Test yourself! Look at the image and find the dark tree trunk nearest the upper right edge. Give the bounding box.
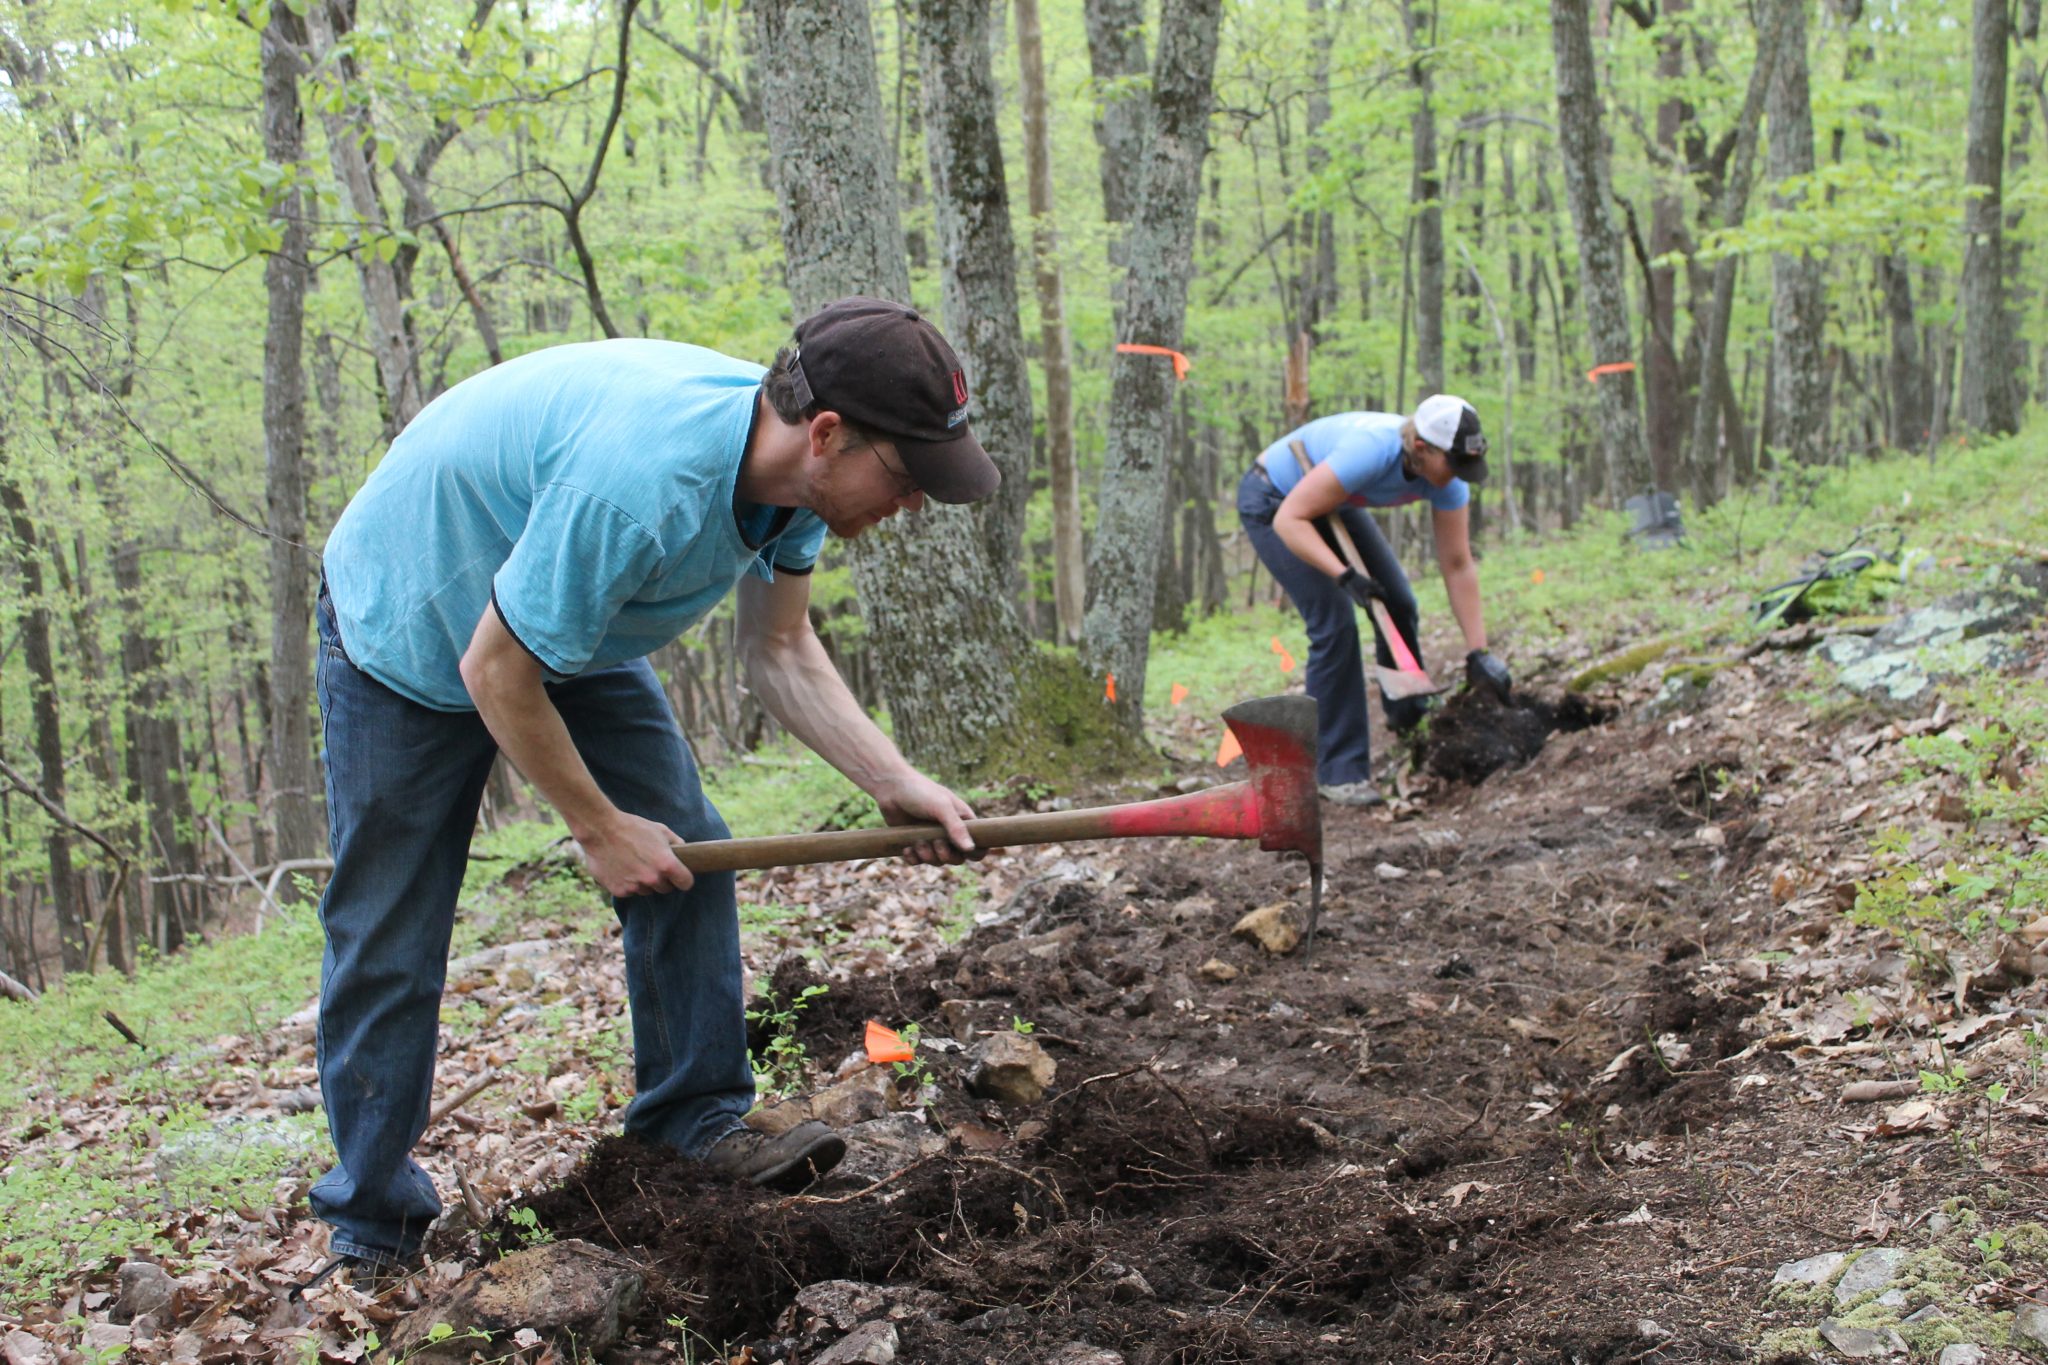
[1956,0,2019,436]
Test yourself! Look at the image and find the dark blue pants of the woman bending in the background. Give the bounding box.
[1237,467,1430,786]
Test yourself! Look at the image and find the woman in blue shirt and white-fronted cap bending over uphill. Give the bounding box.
[1237,393,1511,806]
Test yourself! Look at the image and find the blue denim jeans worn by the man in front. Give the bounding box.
[311,585,754,1261]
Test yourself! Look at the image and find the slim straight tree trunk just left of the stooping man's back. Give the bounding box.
[262,4,325,857]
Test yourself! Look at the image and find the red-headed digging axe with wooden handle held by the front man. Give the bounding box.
[676,696,1323,956]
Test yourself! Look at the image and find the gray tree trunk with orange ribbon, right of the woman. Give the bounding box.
[1550,0,1653,503]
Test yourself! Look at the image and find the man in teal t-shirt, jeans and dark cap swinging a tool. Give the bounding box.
[311,299,999,1275]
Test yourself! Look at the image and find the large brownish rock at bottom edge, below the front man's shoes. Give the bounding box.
[389,1238,641,1365]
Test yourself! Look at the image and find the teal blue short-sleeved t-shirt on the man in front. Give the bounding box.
[324,340,825,710]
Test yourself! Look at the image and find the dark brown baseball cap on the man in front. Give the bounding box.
[788,295,1004,503]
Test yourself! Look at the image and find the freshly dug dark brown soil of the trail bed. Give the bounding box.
[512,654,2044,1363]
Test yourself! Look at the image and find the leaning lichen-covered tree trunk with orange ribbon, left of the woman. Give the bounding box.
[1081,0,1223,735]
